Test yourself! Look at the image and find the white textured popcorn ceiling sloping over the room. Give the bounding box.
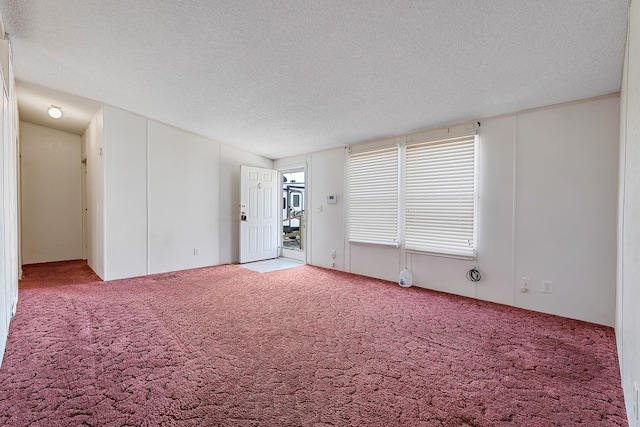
[0,0,629,158]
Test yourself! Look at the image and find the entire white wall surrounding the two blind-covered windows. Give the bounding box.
[275,96,619,326]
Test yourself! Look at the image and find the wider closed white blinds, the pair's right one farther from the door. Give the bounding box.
[405,135,476,256]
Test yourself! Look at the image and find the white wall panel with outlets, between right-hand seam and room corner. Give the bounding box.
[515,98,620,326]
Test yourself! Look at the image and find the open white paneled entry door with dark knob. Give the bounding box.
[240,166,280,264]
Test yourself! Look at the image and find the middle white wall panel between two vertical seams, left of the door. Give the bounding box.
[148,120,220,273]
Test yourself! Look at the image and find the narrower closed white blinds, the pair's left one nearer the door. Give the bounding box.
[348,146,398,245]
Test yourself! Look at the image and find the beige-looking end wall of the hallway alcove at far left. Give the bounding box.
[20,121,82,264]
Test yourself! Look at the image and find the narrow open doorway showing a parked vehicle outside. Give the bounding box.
[281,168,306,262]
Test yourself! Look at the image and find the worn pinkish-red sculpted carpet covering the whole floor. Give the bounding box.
[0,263,627,427]
